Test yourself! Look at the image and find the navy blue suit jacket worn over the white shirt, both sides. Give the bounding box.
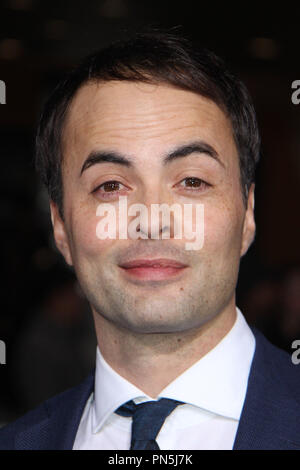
[0,329,300,450]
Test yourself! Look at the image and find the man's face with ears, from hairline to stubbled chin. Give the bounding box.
[51,82,255,333]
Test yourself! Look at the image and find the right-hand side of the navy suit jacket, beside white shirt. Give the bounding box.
[233,329,300,450]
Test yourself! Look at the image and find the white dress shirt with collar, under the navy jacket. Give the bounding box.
[73,308,255,450]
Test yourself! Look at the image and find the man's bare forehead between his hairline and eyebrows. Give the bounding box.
[63,81,236,167]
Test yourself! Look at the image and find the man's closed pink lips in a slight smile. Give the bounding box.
[120,258,187,281]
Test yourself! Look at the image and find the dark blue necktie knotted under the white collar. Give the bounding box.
[115,398,184,450]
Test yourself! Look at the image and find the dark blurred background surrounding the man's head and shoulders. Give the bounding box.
[0,0,300,425]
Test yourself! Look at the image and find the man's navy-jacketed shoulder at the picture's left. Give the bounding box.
[0,372,94,450]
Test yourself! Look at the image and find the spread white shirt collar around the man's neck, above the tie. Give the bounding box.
[92,307,255,432]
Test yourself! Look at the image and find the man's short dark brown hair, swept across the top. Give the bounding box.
[36,30,260,216]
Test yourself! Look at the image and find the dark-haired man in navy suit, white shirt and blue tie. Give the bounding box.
[0,32,300,450]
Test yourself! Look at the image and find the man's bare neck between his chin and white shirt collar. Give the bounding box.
[93,299,236,398]
